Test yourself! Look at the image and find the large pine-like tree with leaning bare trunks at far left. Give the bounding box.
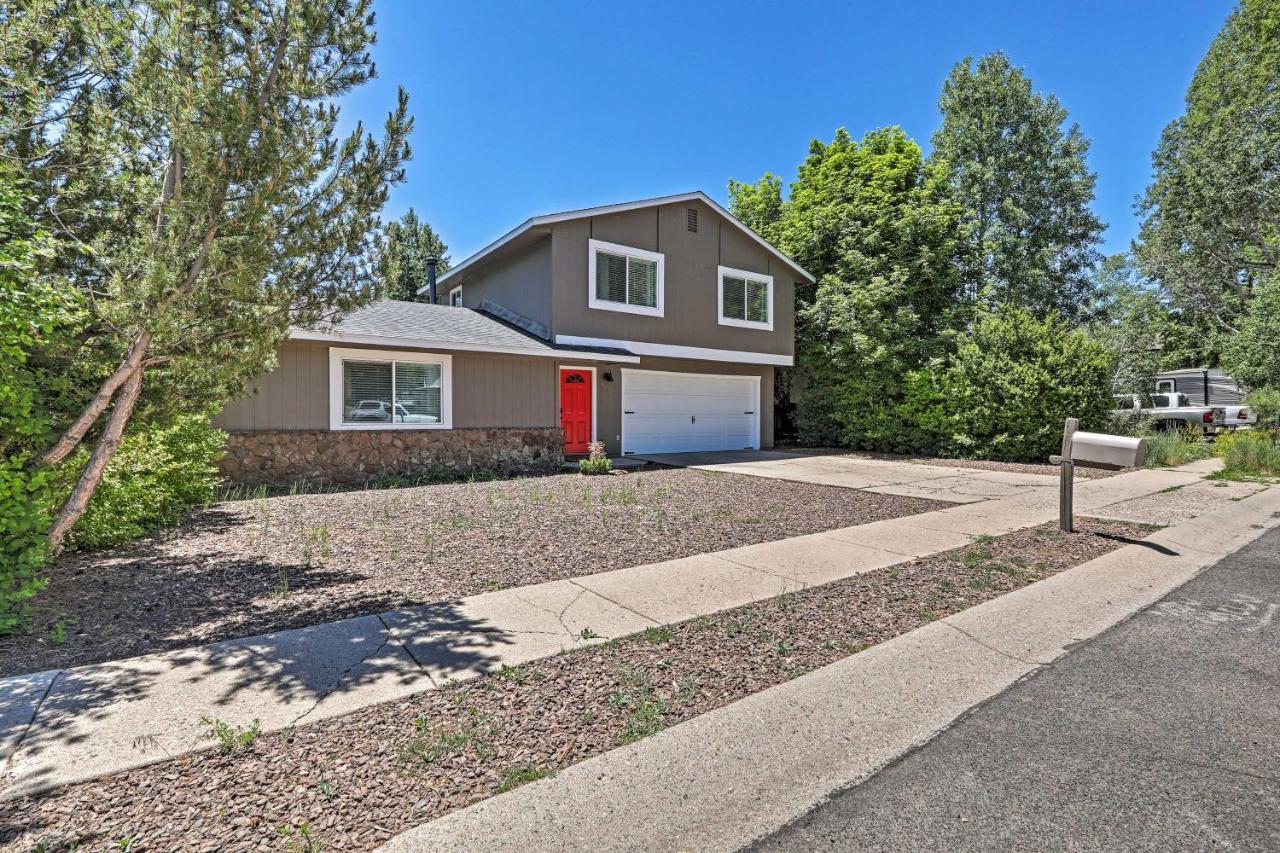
[0,0,411,549]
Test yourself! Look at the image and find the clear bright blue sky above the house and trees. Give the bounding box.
[344,0,1234,260]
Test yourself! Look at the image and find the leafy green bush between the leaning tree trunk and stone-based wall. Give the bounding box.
[64,415,227,549]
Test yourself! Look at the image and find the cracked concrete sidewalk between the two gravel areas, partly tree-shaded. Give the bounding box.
[0,461,1228,797]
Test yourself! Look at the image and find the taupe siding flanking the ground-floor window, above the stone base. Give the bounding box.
[214,341,559,432]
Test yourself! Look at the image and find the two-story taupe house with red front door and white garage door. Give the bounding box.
[215,192,813,482]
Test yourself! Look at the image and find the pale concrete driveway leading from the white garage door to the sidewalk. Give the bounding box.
[639,450,1057,503]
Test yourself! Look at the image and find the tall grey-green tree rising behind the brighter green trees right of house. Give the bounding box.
[932,53,1103,318]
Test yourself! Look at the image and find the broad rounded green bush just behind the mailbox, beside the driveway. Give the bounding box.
[897,309,1115,461]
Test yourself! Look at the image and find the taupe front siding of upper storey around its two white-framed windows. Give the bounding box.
[552,201,801,356]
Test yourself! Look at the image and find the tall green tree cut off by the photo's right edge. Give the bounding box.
[1135,0,1280,332]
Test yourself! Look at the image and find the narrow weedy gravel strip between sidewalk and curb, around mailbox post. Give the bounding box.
[0,514,1151,853]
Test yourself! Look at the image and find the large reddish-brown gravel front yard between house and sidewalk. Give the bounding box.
[0,469,948,675]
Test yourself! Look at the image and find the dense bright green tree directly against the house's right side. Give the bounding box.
[731,127,959,448]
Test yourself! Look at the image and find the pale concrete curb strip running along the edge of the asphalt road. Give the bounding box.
[384,479,1280,853]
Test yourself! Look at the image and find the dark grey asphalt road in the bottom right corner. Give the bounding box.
[750,529,1280,852]
